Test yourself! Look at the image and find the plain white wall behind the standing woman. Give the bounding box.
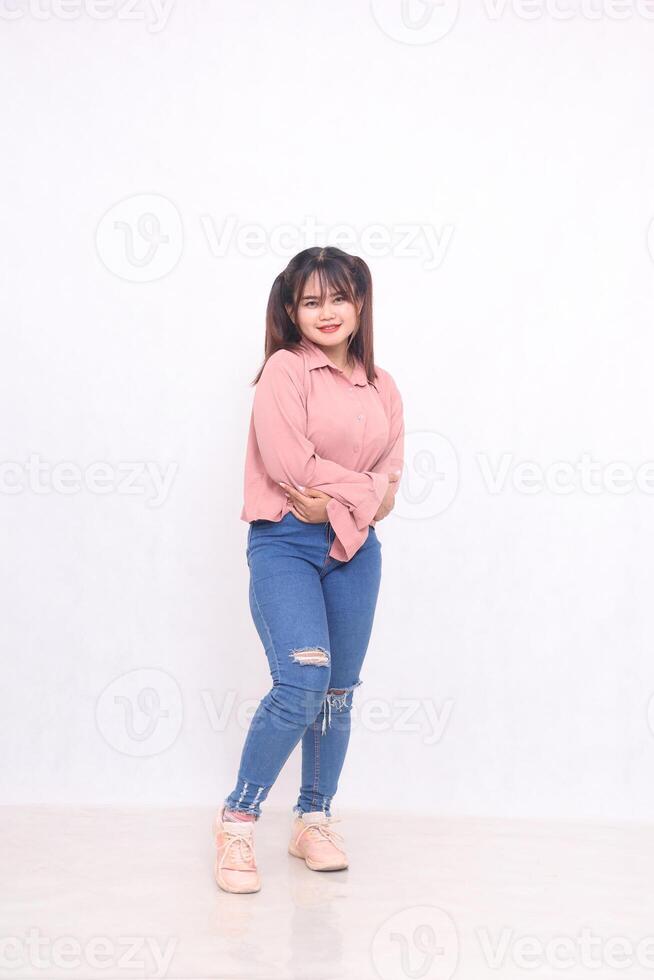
[0,0,654,818]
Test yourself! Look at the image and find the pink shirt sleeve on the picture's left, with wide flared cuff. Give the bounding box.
[252,352,390,561]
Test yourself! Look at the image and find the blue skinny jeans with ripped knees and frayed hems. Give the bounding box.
[225,511,382,820]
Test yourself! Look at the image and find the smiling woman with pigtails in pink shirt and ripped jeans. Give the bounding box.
[215,247,404,892]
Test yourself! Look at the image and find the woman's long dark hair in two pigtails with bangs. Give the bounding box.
[251,245,376,385]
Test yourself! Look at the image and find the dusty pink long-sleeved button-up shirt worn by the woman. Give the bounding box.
[241,337,404,561]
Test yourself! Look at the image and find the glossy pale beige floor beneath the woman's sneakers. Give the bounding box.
[0,807,654,980]
